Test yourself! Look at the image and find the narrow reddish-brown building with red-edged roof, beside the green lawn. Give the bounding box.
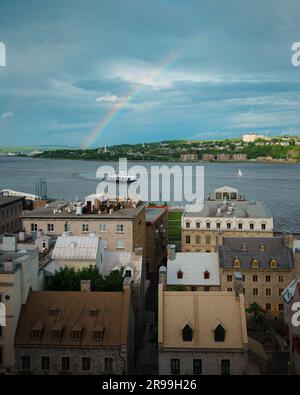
[145,206,168,273]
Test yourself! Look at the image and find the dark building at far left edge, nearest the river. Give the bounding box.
[0,196,23,235]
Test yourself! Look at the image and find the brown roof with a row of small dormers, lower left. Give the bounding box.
[15,289,131,348]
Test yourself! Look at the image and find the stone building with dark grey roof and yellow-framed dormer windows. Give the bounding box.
[219,237,294,318]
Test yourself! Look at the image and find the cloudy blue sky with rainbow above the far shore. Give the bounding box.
[0,0,300,148]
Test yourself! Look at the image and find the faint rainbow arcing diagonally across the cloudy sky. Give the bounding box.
[81,50,182,149]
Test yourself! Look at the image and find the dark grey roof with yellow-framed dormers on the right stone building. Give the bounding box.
[219,237,293,270]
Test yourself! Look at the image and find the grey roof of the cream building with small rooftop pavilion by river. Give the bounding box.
[184,200,272,218]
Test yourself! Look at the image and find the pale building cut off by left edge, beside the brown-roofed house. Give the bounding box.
[0,251,42,373]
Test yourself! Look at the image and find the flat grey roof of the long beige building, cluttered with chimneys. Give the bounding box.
[22,202,144,219]
